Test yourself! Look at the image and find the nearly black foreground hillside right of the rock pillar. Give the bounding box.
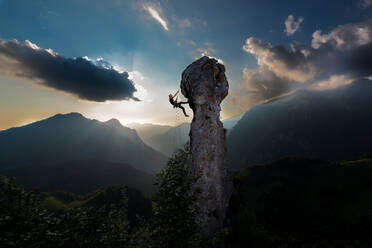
[230,157,372,247]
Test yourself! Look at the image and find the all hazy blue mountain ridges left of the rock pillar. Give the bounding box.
[0,110,243,194]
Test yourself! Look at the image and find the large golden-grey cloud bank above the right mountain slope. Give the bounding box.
[235,19,372,108]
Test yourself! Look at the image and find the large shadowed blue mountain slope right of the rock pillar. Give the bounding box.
[228,80,372,169]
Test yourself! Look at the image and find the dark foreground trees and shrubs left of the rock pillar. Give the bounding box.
[0,146,198,248]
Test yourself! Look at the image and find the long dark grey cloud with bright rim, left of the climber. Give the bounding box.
[0,39,139,102]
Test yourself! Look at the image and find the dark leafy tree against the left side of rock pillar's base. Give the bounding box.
[152,146,199,248]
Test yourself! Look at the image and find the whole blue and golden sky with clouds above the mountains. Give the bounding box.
[0,0,372,129]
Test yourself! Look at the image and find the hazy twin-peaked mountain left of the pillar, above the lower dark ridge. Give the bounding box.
[0,113,166,173]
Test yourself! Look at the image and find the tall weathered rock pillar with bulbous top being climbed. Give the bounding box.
[181,57,232,237]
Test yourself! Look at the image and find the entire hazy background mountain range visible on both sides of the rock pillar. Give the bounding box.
[0,80,372,193]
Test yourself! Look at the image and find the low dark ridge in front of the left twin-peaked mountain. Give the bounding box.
[2,160,155,195]
